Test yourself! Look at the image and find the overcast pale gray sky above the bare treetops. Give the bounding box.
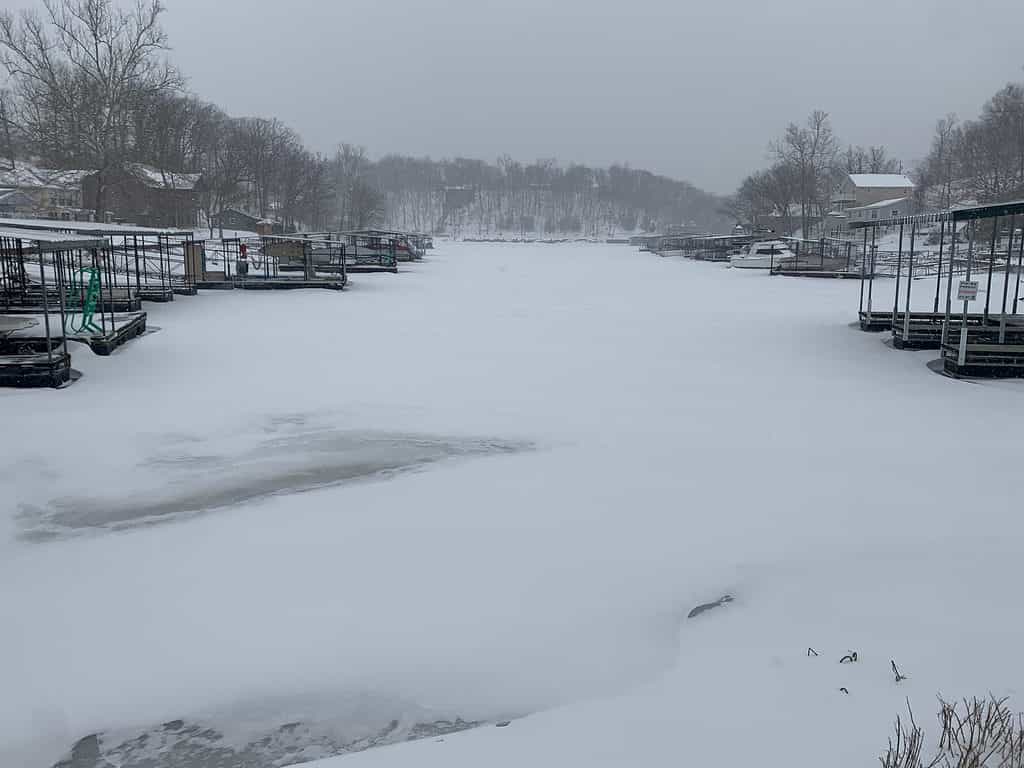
[155,0,1024,193]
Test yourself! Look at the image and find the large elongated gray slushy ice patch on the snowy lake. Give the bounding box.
[18,423,532,541]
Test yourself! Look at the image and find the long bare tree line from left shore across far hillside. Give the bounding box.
[0,0,723,234]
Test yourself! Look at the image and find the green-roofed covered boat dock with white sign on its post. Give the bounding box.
[851,201,1024,377]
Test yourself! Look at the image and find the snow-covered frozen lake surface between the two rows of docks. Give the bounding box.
[0,243,1024,768]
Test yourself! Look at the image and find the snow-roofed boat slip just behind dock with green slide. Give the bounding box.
[0,219,197,308]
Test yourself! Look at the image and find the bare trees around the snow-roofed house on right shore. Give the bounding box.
[726,83,1024,234]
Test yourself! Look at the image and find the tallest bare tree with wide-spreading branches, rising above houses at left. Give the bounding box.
[0,0,182,215]
